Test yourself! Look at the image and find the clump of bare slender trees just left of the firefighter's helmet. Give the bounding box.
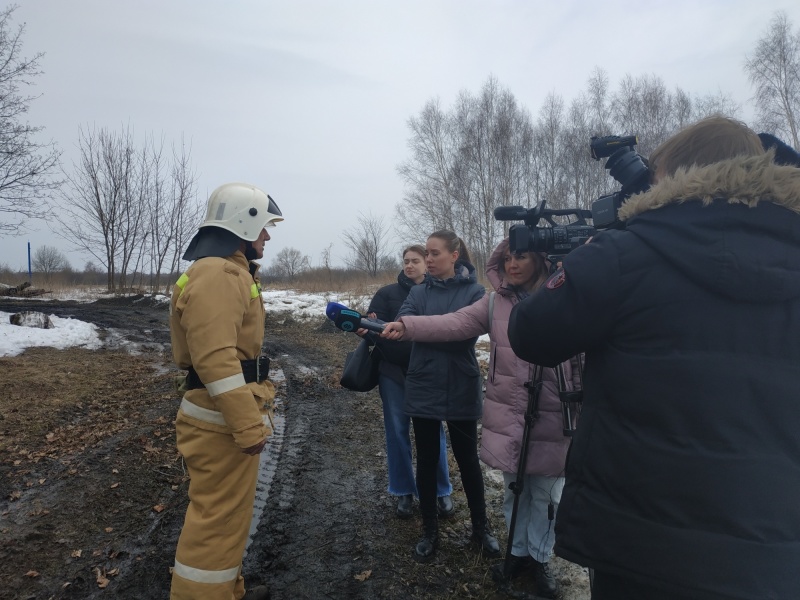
[57,129,201,291]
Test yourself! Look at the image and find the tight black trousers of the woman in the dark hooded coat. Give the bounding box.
[411,417,486,523]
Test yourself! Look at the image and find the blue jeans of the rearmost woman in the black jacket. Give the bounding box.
[378,374,453,496]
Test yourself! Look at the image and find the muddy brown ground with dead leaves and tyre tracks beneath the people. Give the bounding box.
[0,298,589,600]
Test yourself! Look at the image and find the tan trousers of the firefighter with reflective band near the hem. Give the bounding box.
[170,419,259,600]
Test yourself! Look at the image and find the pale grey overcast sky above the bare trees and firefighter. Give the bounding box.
[6,0,800,269]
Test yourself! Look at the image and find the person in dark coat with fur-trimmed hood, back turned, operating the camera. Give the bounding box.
[509,117,800,600]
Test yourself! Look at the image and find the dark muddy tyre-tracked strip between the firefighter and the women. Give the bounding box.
[244,355,383,598]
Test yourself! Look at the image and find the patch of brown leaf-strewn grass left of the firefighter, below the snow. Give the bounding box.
[0,349,177,474]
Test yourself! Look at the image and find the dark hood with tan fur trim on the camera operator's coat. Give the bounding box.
[601,152,800,303]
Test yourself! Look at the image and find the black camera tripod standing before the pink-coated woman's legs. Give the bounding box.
[499,355,593,599]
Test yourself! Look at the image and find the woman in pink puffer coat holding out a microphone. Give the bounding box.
[382,239,579,598]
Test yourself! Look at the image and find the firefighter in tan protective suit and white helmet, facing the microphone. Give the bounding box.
[170,183,283,600]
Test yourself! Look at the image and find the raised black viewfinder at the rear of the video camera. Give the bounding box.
[589,135,650,229]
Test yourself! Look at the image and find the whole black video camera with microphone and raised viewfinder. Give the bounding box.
[494,135,650,264]
